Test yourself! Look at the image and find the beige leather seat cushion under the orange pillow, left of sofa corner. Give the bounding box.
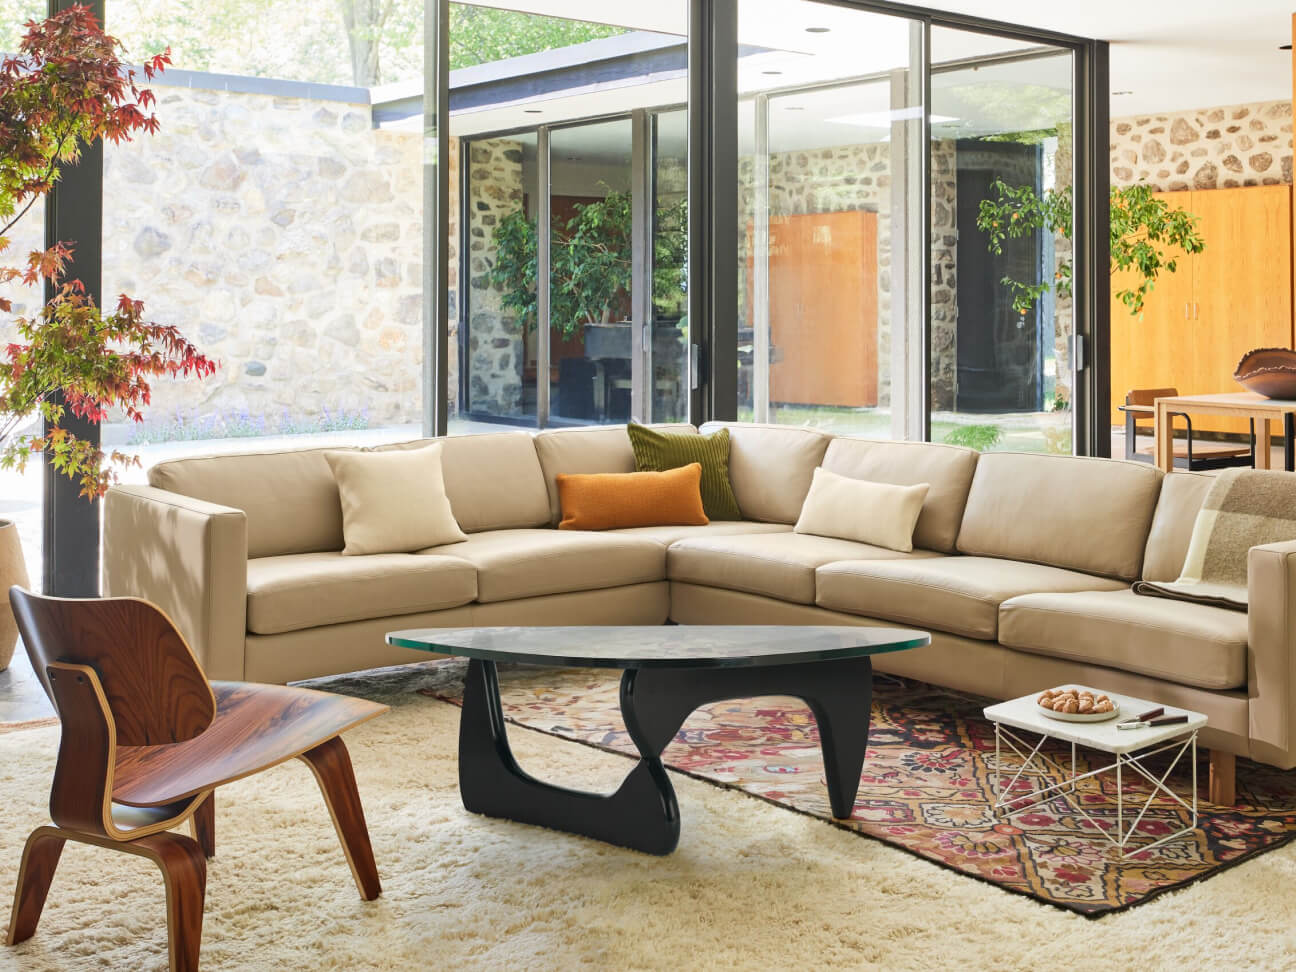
[420,529,666,604]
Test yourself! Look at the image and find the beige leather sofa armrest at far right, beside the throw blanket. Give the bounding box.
[1247,540,1296,770]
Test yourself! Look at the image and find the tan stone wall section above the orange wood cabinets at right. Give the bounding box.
[1111,101,1292,192]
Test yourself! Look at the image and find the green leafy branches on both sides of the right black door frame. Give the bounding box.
[976,180,1205,314]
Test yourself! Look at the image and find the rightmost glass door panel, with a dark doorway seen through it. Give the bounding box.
[931,29,1074,454]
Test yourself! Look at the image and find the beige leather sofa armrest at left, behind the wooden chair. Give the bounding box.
[104,486,248,680]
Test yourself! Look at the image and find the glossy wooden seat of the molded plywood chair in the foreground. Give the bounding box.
[113,682,388,807]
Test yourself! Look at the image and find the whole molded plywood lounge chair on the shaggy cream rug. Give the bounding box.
[6,587,388,969]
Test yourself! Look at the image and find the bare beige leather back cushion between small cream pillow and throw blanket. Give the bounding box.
[958,452,1163,581]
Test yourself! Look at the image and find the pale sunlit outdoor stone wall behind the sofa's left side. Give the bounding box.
[104,86,422,426]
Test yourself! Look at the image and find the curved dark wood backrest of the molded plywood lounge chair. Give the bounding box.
[9,587,216,746]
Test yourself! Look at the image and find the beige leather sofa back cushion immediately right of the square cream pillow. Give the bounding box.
[441,432,550,533]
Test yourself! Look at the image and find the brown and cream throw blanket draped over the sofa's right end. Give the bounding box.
[1134,469,1296,610]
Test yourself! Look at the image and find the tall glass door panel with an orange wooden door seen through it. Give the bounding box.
[739,0,924,438]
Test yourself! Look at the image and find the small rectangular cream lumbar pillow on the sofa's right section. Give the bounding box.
[793,467,932,553]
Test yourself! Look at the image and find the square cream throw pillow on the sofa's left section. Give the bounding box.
[324,442,468,556]
